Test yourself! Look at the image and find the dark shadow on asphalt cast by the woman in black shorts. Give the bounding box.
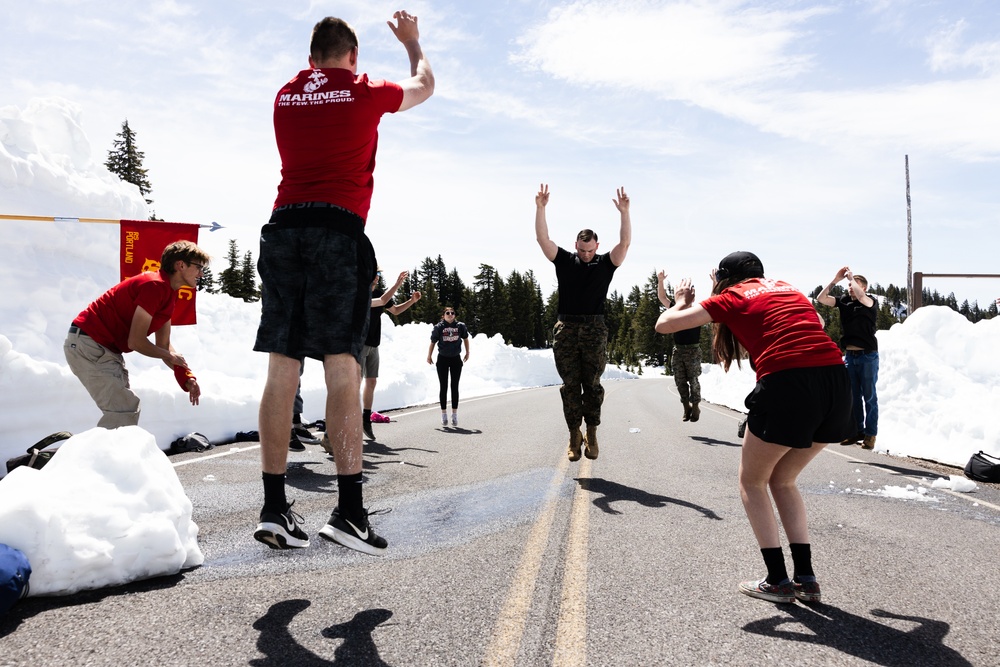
[743,604,972,667]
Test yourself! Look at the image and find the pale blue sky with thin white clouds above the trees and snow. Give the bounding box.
[0,0,1000,307]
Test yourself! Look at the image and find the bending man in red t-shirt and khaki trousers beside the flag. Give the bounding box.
[63,241,211,428]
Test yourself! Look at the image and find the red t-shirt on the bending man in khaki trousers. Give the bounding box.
[73,271,177,354]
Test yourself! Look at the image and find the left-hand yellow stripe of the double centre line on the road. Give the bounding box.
[483,456,569,667]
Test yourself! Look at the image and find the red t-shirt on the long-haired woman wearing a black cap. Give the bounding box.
[701,278,844,380]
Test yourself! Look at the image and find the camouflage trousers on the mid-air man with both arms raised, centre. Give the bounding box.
[552,321,608,430]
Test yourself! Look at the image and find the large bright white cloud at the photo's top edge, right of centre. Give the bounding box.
[515,0,828,96]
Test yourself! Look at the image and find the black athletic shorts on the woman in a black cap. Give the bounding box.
[744,364,855,449]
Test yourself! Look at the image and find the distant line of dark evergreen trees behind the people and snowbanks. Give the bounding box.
[198,241,997,373]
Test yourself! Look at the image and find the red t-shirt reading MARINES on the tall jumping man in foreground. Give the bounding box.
[274,68,403,219]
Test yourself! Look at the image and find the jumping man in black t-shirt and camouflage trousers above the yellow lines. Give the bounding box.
[535,184,632,461]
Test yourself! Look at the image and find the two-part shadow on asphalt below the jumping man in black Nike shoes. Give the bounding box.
[249,600,392,667]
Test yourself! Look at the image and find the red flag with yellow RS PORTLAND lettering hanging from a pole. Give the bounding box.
[120,220,198,326]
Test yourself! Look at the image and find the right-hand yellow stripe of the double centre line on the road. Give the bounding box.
[552,458,590,667]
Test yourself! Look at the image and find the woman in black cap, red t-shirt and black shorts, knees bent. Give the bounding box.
[656,251,853,602]
